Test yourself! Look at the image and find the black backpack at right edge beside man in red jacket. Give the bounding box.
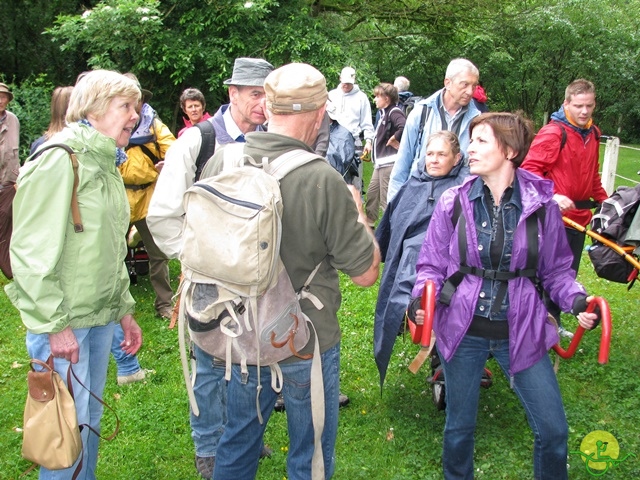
[588,184,640,288]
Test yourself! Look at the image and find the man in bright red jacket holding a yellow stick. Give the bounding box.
[522,79,608,336]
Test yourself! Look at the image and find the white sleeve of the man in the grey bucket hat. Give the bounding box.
[147,128,202,258]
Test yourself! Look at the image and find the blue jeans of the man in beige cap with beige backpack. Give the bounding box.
[213,344,340,480]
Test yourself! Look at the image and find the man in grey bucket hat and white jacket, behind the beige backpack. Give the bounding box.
[147,58,273,479]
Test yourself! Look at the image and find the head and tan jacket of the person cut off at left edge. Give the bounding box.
[0,83,20,185]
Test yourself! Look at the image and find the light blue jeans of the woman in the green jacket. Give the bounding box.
[27,322,115,480]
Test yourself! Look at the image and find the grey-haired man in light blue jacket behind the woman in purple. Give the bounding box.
[387,58,480,202]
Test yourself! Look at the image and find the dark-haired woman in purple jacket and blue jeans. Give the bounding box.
[410,113,598,480]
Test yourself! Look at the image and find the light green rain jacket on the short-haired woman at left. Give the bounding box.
[5,123,135,334]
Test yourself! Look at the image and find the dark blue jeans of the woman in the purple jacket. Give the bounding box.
[442,335,568,480]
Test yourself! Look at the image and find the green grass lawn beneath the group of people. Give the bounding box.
[0,149,640,480]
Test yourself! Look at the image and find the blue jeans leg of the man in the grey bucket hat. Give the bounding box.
[190,344,227,457]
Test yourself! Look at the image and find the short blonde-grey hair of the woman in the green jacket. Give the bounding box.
[67,70,142,123]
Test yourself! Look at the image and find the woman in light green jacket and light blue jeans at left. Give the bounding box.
[6,70,142,480]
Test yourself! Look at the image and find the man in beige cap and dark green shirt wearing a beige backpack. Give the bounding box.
[203,63,380,480]
